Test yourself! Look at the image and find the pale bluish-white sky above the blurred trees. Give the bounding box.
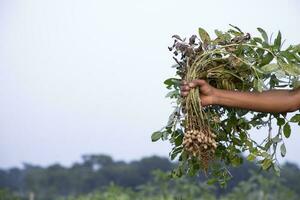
[0,0,300,168]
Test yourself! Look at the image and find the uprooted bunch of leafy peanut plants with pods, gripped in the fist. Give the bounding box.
[152,25,300,186]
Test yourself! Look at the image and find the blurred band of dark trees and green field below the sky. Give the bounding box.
[0,155,300,200]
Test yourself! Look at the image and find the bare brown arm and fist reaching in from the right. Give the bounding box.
[180,79,300,113]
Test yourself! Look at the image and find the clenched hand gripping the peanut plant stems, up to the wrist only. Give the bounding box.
[180,79,216,106]
